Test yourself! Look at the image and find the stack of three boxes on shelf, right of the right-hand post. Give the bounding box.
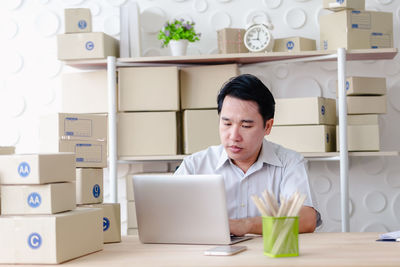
[337,77,387,151]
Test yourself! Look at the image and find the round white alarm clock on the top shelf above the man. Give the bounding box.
[244,24,274,52]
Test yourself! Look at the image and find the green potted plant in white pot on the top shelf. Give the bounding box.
[158,19,201,56]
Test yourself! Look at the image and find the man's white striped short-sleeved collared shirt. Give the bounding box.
[175,139,314,219]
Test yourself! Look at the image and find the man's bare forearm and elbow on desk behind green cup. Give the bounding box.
[229,206,317,236]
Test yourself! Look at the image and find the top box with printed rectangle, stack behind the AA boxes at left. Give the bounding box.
[39,113,107,144]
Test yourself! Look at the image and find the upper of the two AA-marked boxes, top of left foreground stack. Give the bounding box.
[0,153,75,184]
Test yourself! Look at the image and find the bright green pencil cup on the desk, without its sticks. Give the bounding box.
[262,216,299,258]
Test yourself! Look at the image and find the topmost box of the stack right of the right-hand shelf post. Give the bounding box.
[340,77,386,95]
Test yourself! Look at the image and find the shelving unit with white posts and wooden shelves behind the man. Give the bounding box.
[67,48,399,232]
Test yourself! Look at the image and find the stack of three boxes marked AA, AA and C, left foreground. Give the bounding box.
[0,153,103,264]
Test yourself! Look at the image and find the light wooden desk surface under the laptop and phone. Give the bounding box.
[10,233,400,267]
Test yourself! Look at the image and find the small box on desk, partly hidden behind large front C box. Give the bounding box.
[80,203,121,243]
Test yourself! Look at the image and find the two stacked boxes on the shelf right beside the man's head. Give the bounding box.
[265,97,336,152]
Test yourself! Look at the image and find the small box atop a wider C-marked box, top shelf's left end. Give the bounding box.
[57,8,119,60]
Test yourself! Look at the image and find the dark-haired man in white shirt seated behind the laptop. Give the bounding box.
[175,74,319,236]
